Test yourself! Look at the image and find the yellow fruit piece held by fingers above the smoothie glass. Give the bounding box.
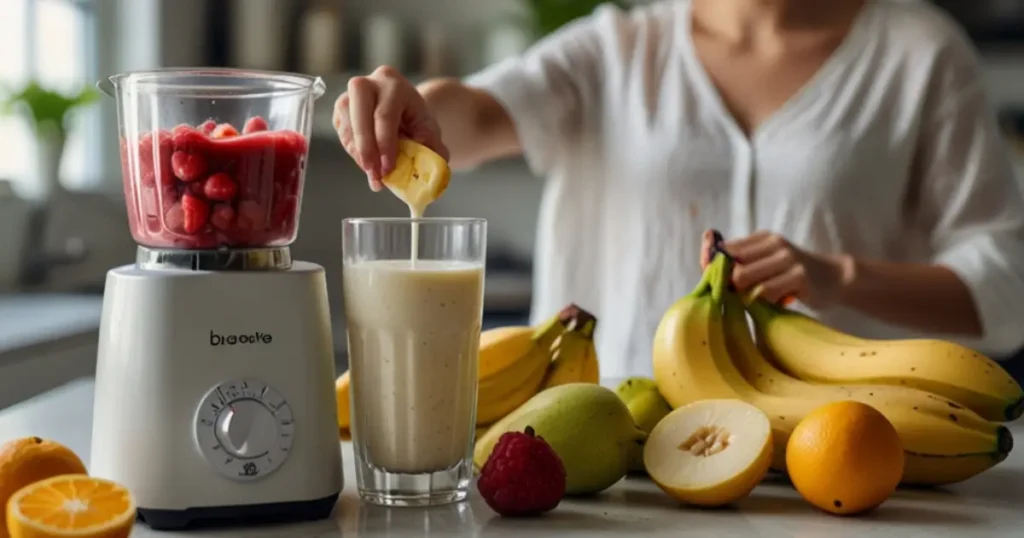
[381,138,452,216]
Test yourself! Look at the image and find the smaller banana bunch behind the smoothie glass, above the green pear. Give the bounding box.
[476,304,600,426]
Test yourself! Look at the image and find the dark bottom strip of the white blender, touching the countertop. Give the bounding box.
[138,492,341,531]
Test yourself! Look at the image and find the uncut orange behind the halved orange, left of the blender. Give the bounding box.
[0,438,86,538]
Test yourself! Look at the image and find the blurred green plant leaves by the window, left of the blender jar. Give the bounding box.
[0,81,99,138]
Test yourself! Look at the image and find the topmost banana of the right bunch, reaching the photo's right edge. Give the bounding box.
[748,300,1024,421]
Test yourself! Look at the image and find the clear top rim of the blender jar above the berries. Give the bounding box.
[96,68,327,99]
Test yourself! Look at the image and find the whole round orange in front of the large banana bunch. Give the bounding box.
[785,402,903,515]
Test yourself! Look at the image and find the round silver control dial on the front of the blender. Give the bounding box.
[195,380,295,481]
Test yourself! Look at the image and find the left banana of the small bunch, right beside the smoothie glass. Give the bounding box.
[476,316,565,425]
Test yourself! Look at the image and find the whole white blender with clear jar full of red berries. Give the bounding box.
[90,69,342,529]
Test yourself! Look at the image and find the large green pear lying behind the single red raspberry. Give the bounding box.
[473,383,647,496]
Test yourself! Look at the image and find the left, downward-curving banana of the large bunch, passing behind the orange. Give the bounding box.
[653,255,1013,484]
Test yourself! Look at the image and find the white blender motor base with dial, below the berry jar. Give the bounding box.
[88,252,344,529]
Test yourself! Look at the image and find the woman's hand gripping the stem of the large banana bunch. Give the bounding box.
[700,231,850,308]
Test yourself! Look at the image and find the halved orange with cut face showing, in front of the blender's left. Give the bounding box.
[7,474,135,538]
